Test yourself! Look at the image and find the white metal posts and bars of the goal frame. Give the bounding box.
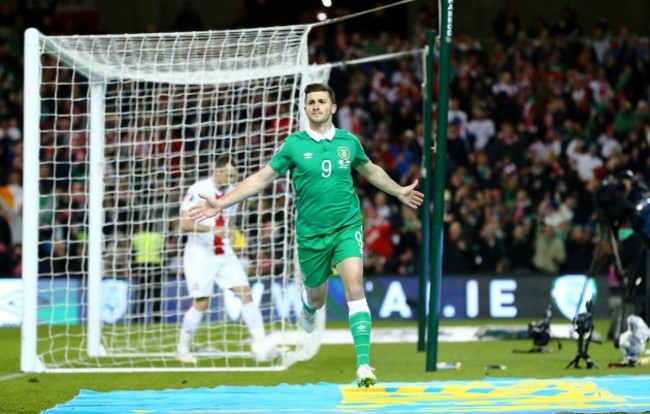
[20,25,330,372]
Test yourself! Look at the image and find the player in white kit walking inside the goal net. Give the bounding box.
[177,156,278,363]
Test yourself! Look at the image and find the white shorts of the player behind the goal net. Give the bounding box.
[183,243,249,298]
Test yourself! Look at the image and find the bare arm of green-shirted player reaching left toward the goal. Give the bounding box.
[189,165,279,221]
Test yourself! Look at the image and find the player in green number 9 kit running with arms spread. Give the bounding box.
[190,83,423,387]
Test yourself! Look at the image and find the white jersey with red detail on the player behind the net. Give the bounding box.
[181,177,237,250]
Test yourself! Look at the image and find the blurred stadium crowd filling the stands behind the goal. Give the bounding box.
[0,0,650,277]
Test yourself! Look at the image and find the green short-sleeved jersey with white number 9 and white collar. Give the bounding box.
[270,129,369,237]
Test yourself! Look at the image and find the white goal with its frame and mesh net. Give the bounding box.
[21,25,329,372]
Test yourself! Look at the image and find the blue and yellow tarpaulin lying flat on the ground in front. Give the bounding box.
[44,375,650,414]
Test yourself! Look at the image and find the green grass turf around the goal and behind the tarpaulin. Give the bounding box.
[0,320,650,414]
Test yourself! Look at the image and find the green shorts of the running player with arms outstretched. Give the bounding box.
[298,223,363,287]
